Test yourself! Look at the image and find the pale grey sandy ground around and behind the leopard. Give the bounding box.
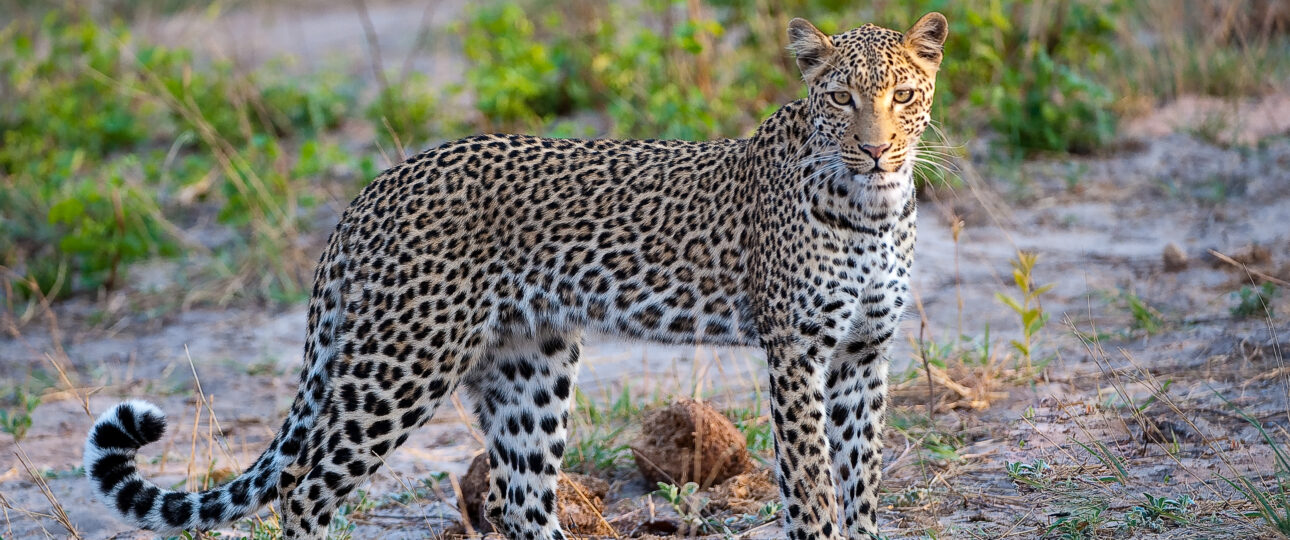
[0,3,1290,539]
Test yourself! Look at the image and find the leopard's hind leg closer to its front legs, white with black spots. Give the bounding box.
[467,331,582,540]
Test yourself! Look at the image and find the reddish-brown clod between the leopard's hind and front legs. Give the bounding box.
[632,400,752,487]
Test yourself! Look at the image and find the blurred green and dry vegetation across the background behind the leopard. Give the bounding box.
[0,0,1290,304]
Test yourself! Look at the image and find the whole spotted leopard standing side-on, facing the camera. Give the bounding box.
[84,13,948,540]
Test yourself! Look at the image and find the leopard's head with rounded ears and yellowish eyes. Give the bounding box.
[788,13,948,184]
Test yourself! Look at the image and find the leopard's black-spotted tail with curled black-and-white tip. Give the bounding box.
[84,230,348,534]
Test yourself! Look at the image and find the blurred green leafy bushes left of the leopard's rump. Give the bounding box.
[0,12,357,300]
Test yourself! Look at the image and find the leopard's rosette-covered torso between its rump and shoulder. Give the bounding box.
[343,135,756,344]
